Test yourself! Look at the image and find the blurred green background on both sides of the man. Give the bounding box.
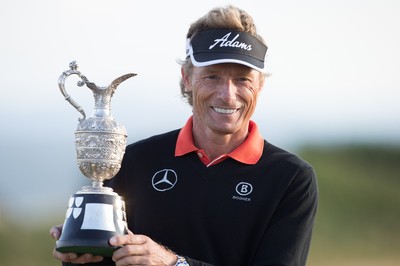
[0,145,400,266]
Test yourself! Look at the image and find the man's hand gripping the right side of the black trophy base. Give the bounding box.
[110,232,177,266]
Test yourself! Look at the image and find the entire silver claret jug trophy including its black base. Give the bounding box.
[56,61,136,257]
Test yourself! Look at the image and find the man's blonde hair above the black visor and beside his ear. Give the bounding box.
[179,5,265,105]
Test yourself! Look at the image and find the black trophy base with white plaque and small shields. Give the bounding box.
[56,192,127,257]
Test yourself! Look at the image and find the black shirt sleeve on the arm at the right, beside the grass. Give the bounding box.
[252,164,318,266]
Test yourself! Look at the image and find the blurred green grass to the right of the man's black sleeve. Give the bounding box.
[301,146,400,266]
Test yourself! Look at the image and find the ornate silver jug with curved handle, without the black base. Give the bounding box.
[58,61,136,192]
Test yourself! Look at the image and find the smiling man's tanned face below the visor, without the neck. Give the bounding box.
[184,64,263,135]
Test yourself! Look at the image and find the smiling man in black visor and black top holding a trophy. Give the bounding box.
[50,6,317,266]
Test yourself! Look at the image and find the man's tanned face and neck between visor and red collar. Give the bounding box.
[182,63,263,164]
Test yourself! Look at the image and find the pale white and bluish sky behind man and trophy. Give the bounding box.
[0,0,400,221]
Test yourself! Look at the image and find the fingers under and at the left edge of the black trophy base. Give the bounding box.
[50,224,103,264]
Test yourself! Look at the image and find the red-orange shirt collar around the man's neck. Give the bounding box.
[175,117,264,165]
